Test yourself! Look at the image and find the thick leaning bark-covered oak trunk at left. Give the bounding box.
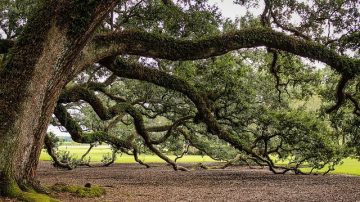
[0,0,116,200]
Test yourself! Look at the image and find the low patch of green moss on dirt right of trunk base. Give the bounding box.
[50,184,106,198]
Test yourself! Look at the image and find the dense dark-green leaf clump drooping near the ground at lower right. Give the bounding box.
[266,111,346,169]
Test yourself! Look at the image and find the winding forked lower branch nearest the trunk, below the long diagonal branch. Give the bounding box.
[54,82,191,171]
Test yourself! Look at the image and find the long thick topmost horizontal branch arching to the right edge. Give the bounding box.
[88,28,360,75]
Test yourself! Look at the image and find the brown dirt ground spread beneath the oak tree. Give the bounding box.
[2,162,360,202]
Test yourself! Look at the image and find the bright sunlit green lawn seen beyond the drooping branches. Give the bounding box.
[40,145,360,176]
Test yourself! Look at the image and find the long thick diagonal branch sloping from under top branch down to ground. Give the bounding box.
[102,57,332,174]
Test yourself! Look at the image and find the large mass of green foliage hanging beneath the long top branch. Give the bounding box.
[66,34,349,170]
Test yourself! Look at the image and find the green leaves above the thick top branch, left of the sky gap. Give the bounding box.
[117,0,221,38]
